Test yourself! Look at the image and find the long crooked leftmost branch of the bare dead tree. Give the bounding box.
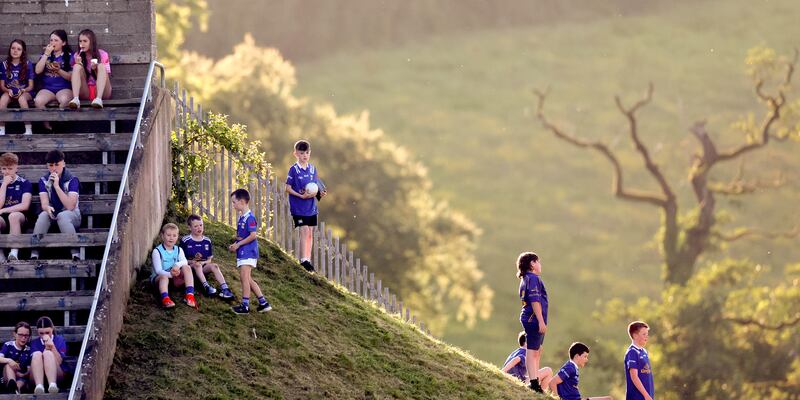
[534,89,667,207]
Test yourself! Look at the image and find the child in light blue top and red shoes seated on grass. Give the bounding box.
[150,223,197,308]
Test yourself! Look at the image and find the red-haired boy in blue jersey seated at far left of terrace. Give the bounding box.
[0,153,33,262]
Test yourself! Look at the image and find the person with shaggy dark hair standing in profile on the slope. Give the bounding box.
[517,252,548,393]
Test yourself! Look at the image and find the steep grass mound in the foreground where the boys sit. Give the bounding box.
[106,211,544,399]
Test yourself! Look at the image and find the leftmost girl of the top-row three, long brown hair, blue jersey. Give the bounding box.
[0,39,36,135]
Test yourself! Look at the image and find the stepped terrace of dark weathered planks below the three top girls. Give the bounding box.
[0,98,140,399]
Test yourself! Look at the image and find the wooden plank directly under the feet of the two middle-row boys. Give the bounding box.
[0,260,100,279]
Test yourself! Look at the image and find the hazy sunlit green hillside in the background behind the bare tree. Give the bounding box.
[297,0,800,392]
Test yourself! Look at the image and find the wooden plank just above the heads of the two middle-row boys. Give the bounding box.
[0,133,131,153]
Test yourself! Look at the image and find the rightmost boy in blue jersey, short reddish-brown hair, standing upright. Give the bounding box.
[625,321,655,400]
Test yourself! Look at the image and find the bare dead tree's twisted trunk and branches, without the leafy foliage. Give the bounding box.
[534,50,800,285]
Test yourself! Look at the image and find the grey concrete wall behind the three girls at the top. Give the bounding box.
[0,0,156,99]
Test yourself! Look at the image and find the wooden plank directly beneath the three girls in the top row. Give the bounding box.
[0,107,139,122]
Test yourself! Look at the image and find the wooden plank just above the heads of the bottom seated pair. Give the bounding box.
[0,290,94,312]
